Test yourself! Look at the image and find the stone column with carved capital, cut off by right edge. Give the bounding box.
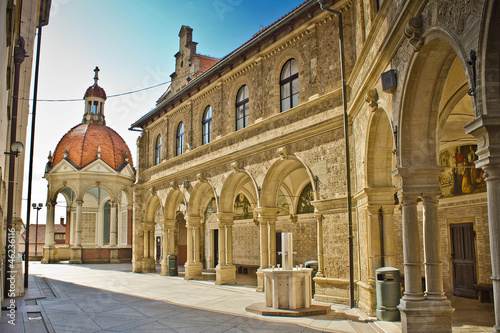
[465,115,500,332]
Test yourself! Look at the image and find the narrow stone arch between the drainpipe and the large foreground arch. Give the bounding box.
[365,108,394,187]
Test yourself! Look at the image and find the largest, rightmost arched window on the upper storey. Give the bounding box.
[280,58,299,112]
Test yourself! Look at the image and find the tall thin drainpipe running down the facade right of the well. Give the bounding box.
[317,0,354,308]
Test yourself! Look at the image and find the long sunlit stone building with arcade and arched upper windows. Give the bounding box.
[131,0,500,331]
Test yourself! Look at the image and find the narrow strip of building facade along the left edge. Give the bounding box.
[0,0,50,301]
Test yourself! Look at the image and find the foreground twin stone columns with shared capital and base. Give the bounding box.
[398,166,454,332]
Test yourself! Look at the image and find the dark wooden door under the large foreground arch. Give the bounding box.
[450,223,477,298]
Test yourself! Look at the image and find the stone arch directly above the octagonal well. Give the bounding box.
[260,156,319,207]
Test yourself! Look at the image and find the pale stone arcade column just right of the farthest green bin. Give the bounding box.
[184,216,203,280]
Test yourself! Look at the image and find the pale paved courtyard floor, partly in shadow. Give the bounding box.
[0,262,494,333]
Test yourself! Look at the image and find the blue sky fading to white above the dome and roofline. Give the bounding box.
[22,0,303,223]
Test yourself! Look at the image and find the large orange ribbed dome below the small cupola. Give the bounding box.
[52,124,133,171]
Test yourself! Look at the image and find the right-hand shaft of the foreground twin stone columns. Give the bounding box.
[422,195,446,300]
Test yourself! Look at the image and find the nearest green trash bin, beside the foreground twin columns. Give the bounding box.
[375,267,401,321]
